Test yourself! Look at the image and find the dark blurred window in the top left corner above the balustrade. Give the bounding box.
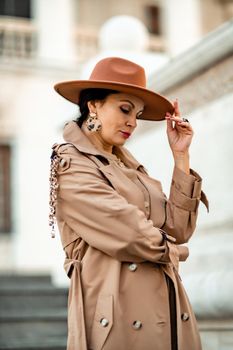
[0,0,31,18]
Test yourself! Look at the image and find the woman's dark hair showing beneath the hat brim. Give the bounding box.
[76,88,119,128]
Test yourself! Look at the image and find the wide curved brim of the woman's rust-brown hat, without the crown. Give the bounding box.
[54,80,174,120]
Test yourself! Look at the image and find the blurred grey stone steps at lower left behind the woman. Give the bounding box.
[0,275,68,350]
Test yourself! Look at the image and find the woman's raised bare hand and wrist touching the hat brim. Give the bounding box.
[165,100,193,174]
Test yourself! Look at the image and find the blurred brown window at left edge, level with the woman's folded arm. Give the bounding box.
[0,145,11,233]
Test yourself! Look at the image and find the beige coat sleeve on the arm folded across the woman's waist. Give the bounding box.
[56,147,179,264]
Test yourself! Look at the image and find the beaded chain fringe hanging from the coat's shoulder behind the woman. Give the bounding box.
[49,152,60,238]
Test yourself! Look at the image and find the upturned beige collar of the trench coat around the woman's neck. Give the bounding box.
[63,121,141,169]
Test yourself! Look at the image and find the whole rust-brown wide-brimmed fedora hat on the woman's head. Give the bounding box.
[54,57,174,120]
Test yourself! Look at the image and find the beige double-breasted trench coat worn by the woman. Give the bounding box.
[53,122,208,350]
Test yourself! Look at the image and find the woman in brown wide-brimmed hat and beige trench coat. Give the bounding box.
[50,57,208,350]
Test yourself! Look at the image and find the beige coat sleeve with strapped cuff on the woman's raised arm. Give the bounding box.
[162,167,209,244]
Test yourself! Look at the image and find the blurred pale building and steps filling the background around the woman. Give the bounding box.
[0,0,233,350]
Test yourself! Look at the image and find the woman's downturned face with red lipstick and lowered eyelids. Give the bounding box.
[88,93,144,147]
